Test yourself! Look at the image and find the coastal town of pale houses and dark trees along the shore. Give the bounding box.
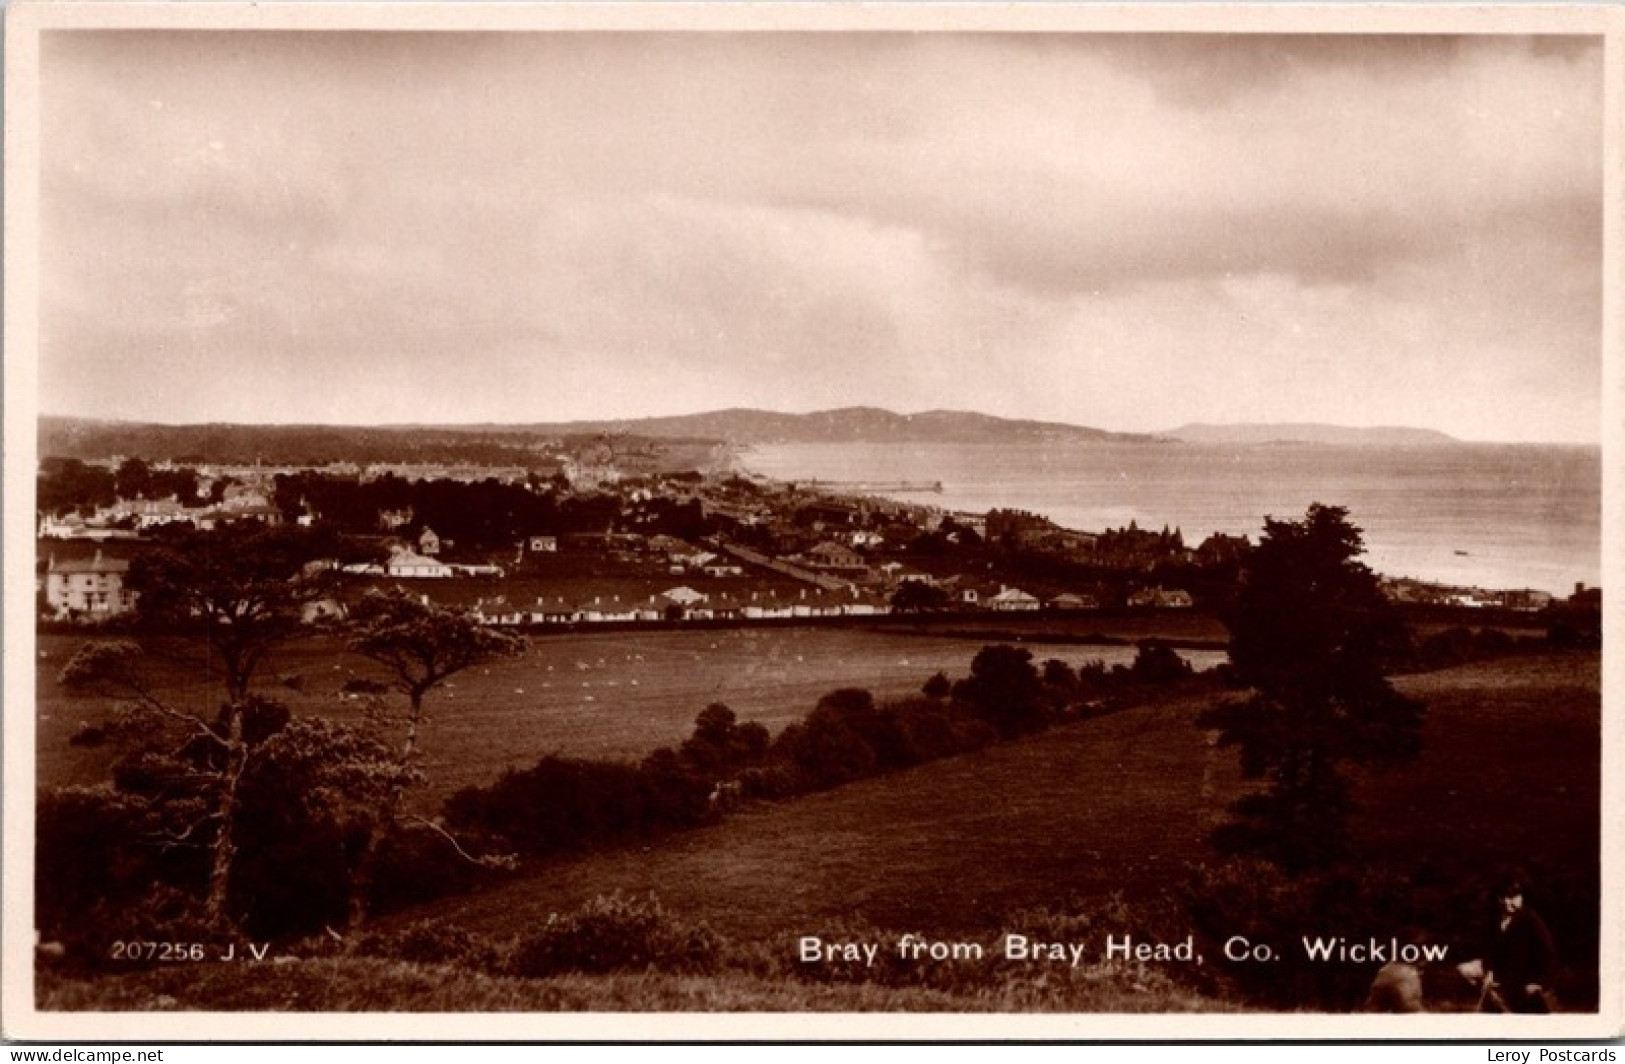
[36,437,1601,627]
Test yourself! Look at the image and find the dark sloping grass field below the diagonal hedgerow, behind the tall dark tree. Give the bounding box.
[380,655,1601,1000]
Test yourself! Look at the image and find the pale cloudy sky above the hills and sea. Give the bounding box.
[39,31,1602,442]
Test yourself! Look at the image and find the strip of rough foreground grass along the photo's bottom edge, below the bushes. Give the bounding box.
[37,958,1235,1012]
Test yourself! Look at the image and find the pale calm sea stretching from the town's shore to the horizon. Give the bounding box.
[738,442,1602,596]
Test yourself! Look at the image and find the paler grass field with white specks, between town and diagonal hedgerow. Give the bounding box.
[36,627,1224,809]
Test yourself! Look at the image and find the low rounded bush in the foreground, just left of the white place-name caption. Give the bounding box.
[510,893,722,978]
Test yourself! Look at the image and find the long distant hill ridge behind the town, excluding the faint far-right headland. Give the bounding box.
[39,406,1154,463]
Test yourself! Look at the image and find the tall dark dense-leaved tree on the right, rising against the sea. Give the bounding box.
[1199,504,1424,869]
